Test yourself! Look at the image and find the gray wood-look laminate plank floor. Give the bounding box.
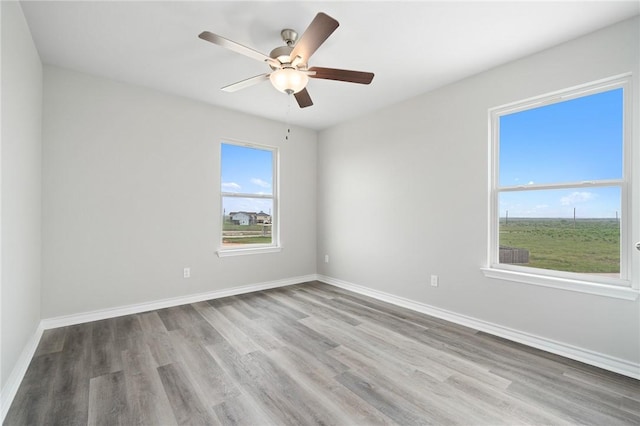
[4,282,640,425]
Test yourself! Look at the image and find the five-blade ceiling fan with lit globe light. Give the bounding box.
[198,12,373,108]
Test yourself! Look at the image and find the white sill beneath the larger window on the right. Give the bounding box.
[481,268,640,300]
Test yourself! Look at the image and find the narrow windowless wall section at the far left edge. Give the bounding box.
[0,1,42,388]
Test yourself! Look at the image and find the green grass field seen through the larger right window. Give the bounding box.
[500,218,620,273]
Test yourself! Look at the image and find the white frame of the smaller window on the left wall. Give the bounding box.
[216,139,282,257]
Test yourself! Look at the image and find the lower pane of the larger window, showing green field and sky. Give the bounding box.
[498,187,621,278]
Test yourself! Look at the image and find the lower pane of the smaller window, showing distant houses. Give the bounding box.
[222,197,273,247]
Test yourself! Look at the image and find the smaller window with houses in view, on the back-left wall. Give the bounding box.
[218,142,278,255]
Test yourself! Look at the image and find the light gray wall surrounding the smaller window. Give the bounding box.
[42,65,317,318]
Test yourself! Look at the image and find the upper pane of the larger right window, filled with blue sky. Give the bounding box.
[499,89,623,186]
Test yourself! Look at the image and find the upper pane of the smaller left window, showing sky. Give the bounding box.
[221,143,273,195]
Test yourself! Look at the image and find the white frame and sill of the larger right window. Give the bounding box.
[482,74,640,300]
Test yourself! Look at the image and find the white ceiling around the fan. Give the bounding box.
[22,0,640,130]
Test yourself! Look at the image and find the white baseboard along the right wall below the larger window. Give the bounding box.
[317,275,640,379]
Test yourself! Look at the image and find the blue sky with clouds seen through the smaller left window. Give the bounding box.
[221,143,273,214]
